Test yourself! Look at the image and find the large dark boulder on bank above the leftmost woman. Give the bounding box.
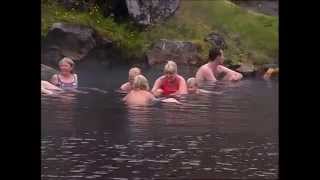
[42,23,112,67]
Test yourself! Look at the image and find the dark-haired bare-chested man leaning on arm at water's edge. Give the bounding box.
[196,48,243,83]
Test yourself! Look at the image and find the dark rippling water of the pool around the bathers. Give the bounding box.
[41,64,278,180]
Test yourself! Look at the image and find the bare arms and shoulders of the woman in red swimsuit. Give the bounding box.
[151,74,188,97]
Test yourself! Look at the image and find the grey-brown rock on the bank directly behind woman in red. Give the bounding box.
[147,39,201,65]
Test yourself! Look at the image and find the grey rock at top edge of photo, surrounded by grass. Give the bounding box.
[126,0,180,25]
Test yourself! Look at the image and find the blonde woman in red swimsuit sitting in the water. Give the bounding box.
[152,61,187,97]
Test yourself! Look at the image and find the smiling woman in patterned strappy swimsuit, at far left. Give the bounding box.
[51,57,78,90]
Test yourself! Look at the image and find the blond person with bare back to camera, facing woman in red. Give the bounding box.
[123,75,180,106]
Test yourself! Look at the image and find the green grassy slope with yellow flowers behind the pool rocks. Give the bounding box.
[42,0,278,65]
